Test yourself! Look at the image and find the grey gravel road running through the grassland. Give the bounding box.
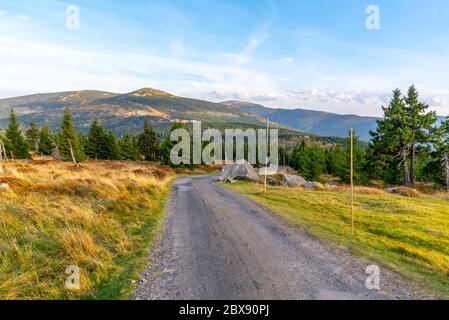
[134,176,424,300]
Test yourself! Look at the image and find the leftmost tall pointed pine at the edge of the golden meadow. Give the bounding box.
[5,111,31,159]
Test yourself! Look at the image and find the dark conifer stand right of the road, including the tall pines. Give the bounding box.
[281,86,449,190]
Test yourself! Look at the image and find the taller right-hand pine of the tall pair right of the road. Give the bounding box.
[405,86,437,186]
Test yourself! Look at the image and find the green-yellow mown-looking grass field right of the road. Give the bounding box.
[224,182,449,299]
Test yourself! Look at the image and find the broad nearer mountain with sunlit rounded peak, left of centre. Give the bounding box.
[0,88,265,133]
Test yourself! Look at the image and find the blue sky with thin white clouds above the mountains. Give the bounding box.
[0,0,449,115]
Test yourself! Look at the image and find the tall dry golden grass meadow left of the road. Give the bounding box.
[0,161,174,299]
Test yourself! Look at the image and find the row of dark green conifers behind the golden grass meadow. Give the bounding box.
[0,111,169,162]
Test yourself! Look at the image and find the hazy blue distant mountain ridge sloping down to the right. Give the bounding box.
[223,101,443,141]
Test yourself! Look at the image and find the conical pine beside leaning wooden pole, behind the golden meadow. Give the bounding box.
[57,111,84,162]
